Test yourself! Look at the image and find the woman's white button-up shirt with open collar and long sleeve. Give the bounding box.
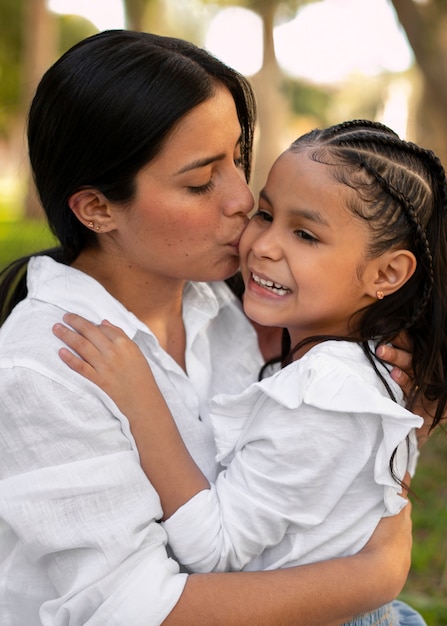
[0,257,262,626]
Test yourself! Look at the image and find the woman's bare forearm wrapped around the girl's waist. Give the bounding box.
[163,505,411,626]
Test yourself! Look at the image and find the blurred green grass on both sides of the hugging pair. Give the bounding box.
[0,221,447,626]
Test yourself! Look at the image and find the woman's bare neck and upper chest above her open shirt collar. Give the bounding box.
[72,250,186,369]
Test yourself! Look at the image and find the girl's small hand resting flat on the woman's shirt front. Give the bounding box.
[53,313,155,415]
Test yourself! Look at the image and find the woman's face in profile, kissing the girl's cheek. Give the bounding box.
[106,87,253,281]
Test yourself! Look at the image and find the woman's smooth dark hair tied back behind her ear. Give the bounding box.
[0,30,255,319]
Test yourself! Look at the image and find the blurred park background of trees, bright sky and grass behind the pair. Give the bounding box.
[0,0,447,626]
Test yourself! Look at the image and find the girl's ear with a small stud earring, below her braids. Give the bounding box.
[370,250,417,297]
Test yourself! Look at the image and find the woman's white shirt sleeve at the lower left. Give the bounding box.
[0,367,186,626]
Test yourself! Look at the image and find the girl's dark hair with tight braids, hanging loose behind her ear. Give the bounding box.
[262,120,447,434]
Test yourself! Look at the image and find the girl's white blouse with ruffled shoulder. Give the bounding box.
[163,341,422,572]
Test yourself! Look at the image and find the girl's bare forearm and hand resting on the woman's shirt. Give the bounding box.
[53,313,209,518]
